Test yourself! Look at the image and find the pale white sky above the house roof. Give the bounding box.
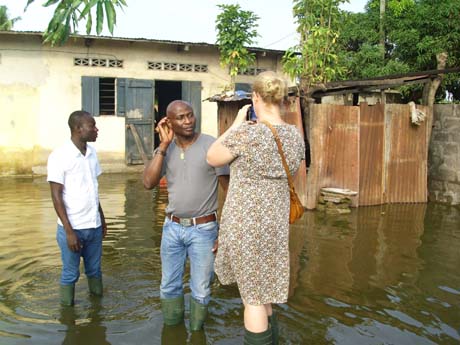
[0,0,367,50]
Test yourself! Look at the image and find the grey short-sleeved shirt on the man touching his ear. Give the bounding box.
[161,134,230,218]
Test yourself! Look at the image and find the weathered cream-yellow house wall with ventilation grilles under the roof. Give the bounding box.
[0,32,281,175]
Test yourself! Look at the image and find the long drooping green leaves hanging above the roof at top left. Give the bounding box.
[25,0,127,45]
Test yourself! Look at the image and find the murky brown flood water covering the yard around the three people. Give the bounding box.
[0,174,460,345]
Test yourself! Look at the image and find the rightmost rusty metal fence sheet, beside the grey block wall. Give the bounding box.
[385,104,428,203]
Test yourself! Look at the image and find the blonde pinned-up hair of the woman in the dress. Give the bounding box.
[252,71,287,104]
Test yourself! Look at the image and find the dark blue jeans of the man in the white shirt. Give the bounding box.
[56,225,102,285]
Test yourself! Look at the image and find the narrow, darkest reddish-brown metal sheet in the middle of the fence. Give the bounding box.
[359,103,385,206]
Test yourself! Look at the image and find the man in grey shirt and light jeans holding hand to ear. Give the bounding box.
[143,100,229,331]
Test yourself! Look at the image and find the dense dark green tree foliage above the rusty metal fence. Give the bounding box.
[338,0,460,105]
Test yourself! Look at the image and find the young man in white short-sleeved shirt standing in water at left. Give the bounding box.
[47,111,107,306]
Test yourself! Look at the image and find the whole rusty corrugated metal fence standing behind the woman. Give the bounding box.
[305,104,432,209]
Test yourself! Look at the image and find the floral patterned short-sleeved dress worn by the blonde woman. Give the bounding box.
[215,122,305,305]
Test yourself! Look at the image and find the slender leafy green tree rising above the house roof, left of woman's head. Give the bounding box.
[216,5,259,90]
